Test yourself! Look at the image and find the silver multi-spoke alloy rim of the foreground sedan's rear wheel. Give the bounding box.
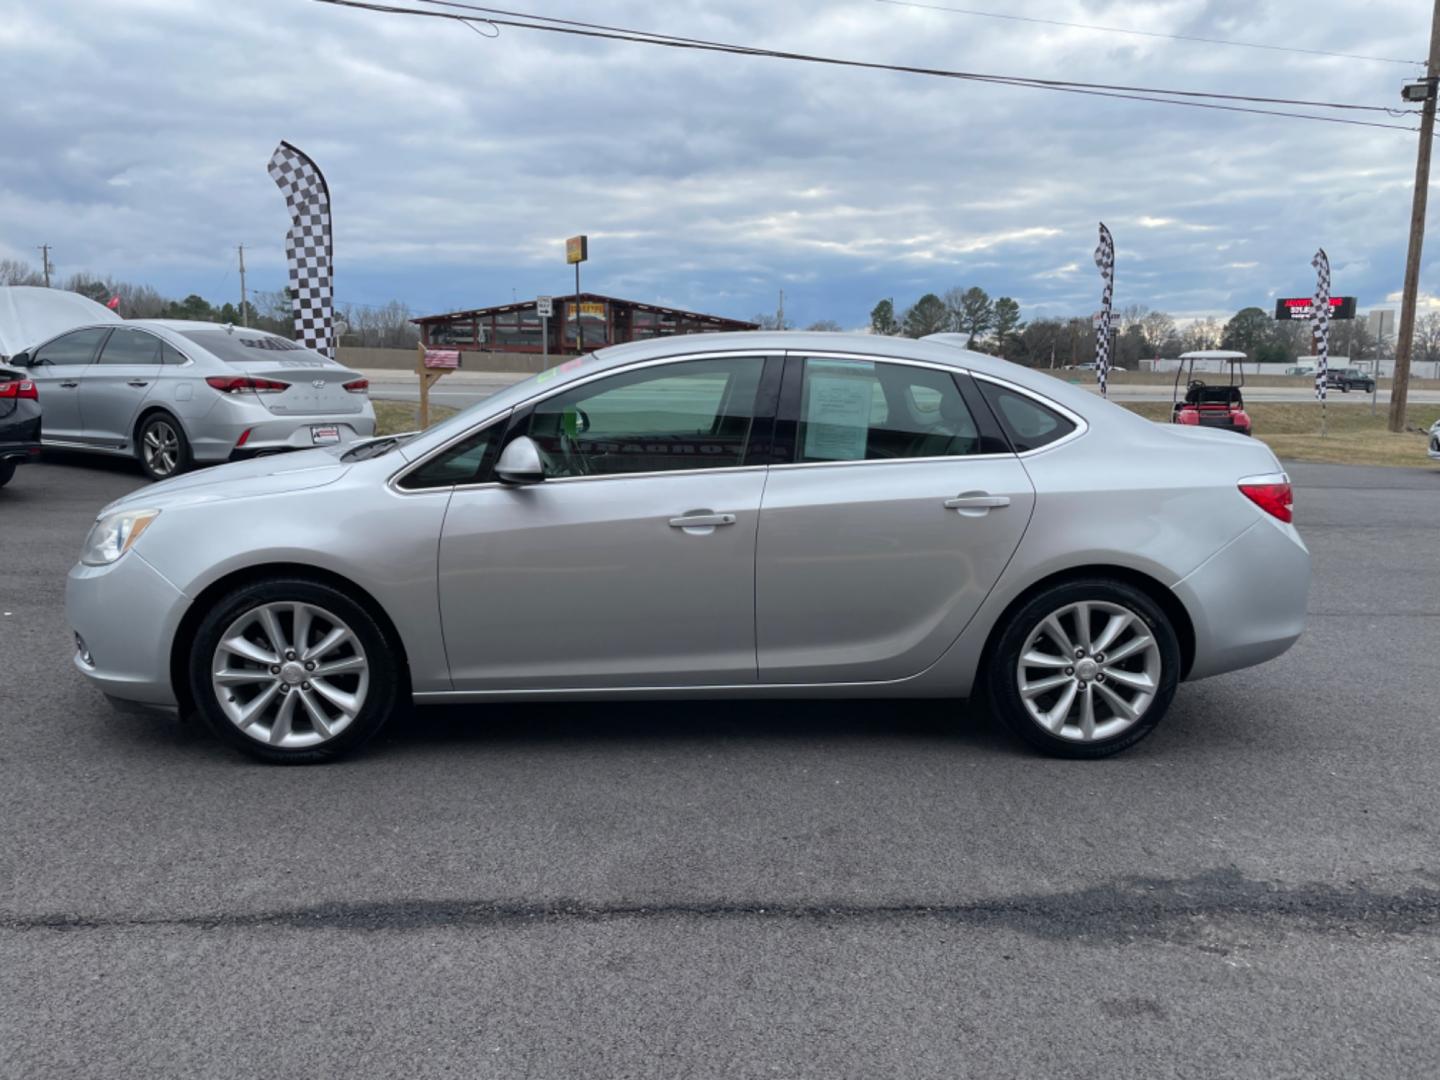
[1015,600,1161,743]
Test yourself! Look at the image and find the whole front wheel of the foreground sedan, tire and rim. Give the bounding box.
[190,579,403,765]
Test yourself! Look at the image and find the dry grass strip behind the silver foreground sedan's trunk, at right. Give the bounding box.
[1116,402,1440,467]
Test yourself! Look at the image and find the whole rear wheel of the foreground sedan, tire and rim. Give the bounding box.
[986,577,1179,757]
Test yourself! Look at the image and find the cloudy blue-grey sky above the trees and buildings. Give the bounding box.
[0,0,1440,327]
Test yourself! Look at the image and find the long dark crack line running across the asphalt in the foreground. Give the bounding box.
[0,868,1440,942]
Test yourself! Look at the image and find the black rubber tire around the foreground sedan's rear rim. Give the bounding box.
[984,577,1181,757]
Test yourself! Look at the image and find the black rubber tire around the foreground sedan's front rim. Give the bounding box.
[189,577,409,765]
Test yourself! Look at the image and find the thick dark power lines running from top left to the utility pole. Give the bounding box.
[315,0,1417,131]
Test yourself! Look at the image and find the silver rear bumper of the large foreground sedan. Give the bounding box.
[1175,517,1310,678]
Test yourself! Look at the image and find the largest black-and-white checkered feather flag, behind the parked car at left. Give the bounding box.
[269,143,336,360]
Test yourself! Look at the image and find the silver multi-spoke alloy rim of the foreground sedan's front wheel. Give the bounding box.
[210,602,370,749]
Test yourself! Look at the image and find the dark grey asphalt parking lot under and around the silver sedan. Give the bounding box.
[0,458,1440,1080]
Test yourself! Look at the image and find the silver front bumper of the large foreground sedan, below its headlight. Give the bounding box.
[65,552,187,708]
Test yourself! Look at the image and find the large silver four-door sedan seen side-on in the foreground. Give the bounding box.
[66,333,1310,762]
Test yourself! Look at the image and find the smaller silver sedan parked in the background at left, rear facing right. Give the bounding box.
[9,318,374,480]
